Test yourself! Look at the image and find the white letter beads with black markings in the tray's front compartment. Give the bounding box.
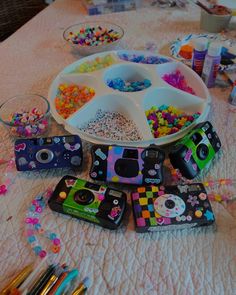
[79,109,141,141]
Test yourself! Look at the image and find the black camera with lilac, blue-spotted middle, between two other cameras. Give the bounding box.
[90,145,165,184]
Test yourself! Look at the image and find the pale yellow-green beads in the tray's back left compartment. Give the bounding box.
[73,54,115,73]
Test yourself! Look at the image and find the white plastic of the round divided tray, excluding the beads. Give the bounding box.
[49,50,211,146]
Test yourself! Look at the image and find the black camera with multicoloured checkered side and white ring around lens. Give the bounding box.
[131,183,215,233]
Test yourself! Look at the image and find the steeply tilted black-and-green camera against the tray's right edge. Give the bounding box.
[169,121,221,179]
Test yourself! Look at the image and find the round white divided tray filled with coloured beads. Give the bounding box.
[48,50,211,146]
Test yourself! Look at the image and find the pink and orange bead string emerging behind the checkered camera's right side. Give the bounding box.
[171,169,236,202]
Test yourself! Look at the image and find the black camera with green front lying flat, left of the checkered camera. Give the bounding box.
[48,176,127,229]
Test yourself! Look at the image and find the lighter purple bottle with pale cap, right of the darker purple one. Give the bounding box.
[202,42,222,88]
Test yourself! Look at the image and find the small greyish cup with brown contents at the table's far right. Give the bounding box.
[200,9,232,33]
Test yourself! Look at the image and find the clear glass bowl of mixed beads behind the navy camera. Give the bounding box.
[0,94,50,138]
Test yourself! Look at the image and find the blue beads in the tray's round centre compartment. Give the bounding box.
[107,78,152,92]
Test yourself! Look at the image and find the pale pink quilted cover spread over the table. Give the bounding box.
[0,0,236,295]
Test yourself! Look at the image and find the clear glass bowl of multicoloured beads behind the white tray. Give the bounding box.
[63,21,124,55]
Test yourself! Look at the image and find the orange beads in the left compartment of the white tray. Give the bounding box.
[55,84,95,119]
